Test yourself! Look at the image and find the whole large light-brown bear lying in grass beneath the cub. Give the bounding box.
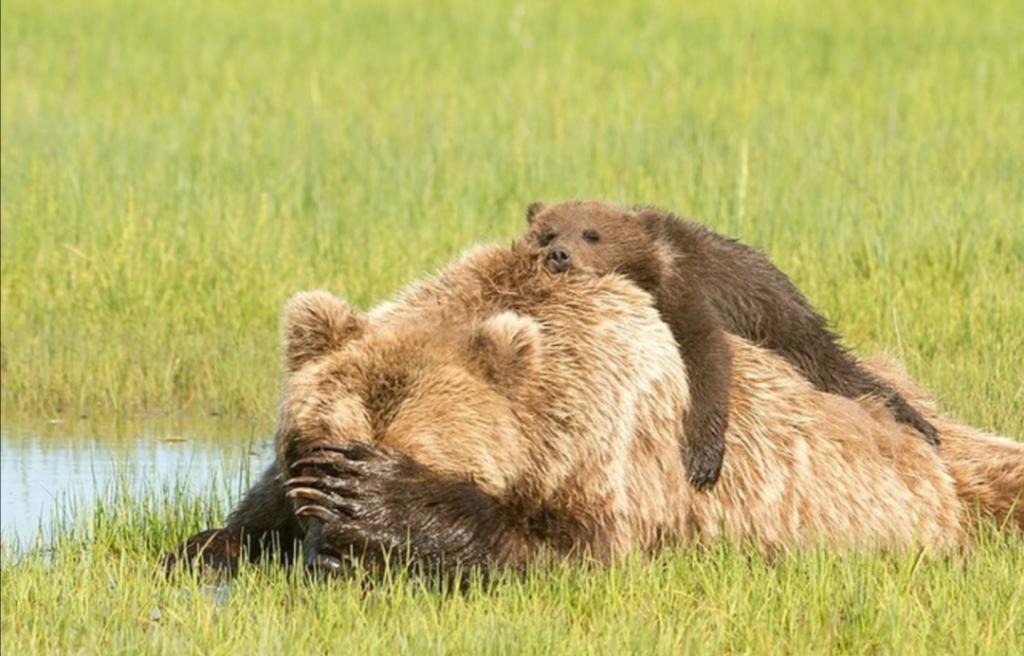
[163,247,1024,571]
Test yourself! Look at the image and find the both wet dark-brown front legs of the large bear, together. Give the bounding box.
[164,443,586,582]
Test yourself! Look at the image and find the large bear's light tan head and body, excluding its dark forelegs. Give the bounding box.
[278,247,1024,560]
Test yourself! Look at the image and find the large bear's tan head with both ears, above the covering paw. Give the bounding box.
[278,292,543,491]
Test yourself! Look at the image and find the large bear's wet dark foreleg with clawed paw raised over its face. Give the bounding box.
[287,443,586,574]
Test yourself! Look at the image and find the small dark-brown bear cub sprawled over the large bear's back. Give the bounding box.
[525,201,938,488]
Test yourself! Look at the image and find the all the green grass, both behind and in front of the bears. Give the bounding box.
[0,0,1024,654]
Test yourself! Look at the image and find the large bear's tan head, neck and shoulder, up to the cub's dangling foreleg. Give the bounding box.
[278,246,689,513]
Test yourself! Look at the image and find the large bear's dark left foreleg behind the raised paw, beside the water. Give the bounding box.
[164,464,302,573]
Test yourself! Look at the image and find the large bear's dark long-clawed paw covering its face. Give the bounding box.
[285,443,415,574]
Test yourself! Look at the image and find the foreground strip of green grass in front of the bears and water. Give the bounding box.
[0,478,1024,654]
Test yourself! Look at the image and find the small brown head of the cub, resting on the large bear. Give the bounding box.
[525,201,664,277]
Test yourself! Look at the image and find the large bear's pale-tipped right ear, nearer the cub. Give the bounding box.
[469,312,543,389]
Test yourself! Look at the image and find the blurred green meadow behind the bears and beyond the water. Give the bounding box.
[0,0,1024,434]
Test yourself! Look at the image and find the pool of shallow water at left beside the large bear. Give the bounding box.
[0,418,272,548]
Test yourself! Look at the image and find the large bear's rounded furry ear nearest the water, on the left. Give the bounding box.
[284,290,366,371]
